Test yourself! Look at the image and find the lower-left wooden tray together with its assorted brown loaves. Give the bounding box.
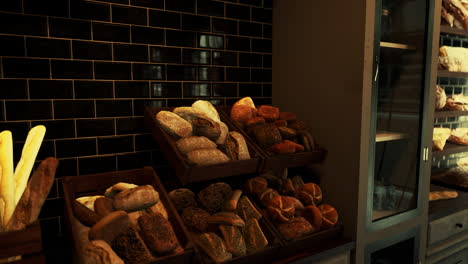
[63,167,193,264]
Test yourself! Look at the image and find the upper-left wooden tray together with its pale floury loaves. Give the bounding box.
[145,100,262,184]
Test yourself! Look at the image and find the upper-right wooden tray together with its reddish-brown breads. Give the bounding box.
[220,97,326,171]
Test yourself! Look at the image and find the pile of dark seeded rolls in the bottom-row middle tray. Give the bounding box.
[169,182,268,263]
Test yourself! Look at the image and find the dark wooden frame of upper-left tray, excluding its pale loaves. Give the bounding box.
[145,107,263,185]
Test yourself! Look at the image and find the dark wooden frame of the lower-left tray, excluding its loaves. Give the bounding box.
[63,167,193,264]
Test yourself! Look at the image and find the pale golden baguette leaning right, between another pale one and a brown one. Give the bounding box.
[15,125,46,206]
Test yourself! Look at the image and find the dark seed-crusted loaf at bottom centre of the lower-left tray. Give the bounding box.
[110,225,153,264]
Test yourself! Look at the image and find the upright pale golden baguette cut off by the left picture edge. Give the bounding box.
[0,131,16,229]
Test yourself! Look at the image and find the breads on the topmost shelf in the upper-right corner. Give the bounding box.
[441,0,468,30]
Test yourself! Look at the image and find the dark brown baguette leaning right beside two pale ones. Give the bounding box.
[7,157,58,231]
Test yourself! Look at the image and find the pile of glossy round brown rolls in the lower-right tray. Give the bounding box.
[245,174,338,240]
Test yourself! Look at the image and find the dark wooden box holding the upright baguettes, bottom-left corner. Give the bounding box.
[0,221,45,264]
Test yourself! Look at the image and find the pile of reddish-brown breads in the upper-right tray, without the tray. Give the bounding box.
[230,97,318,154]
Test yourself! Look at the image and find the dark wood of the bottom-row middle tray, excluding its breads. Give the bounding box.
[162,175,283,264]
